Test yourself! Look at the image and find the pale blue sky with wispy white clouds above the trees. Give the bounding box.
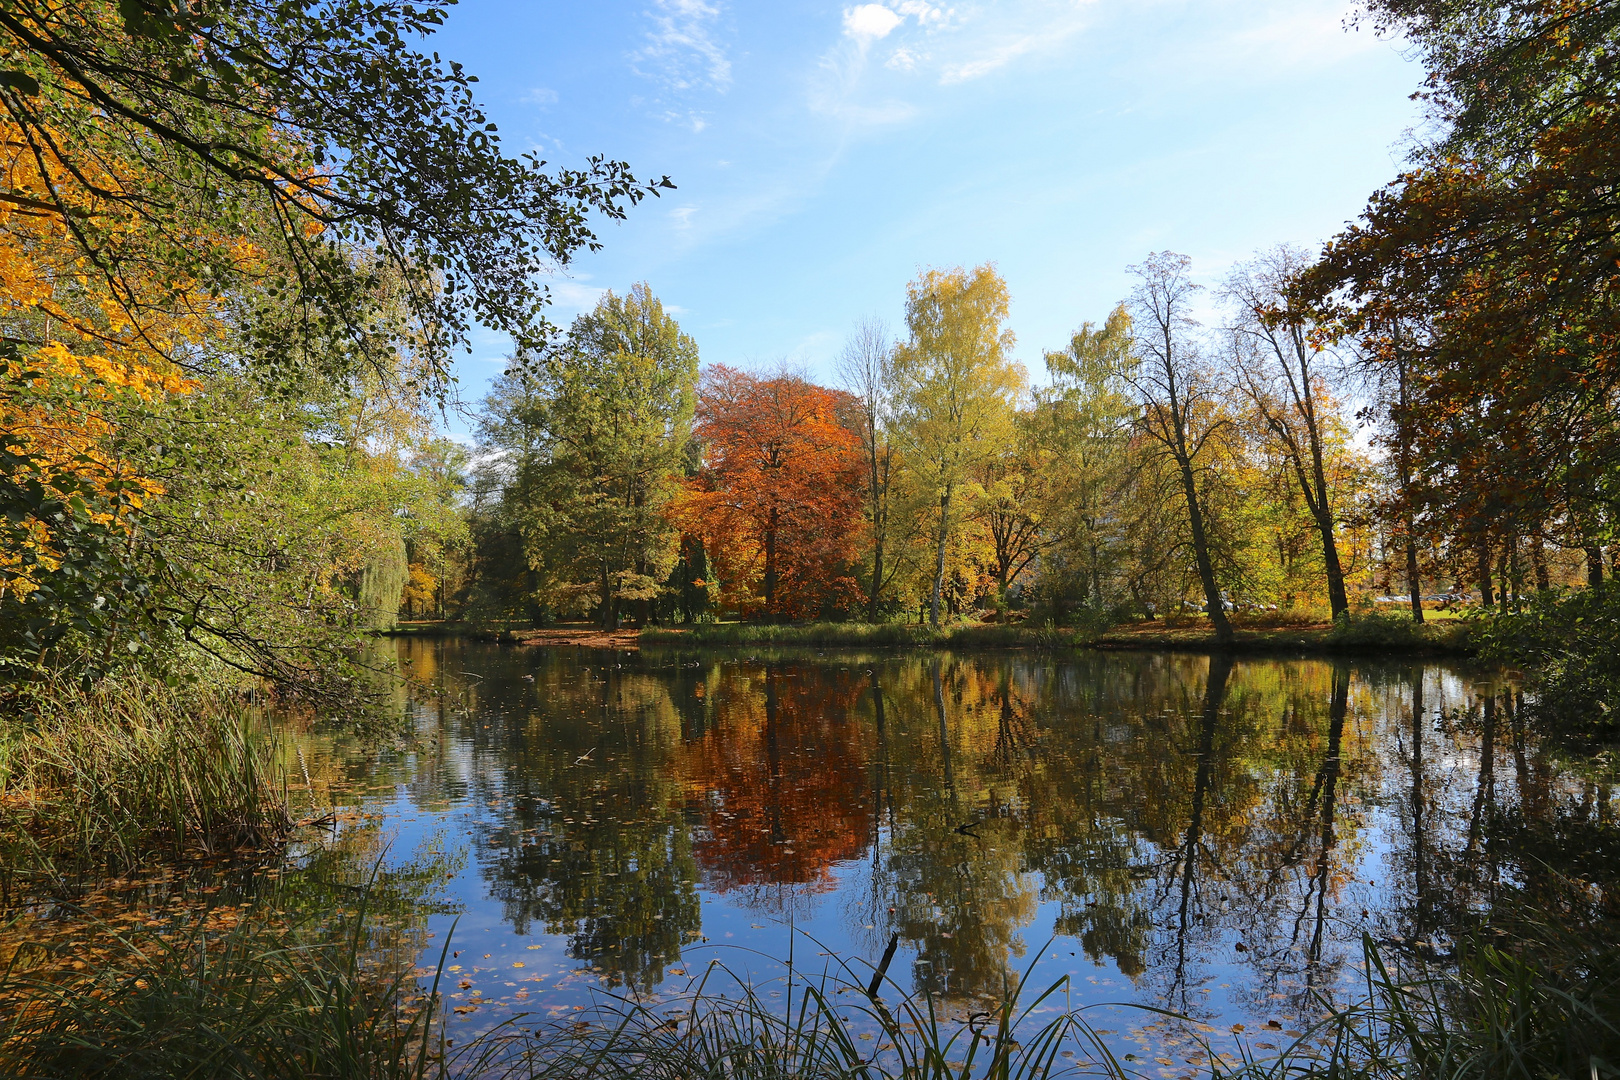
[433,0,1421,431]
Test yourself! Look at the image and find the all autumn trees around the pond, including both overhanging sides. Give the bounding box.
[0,0,1620,725]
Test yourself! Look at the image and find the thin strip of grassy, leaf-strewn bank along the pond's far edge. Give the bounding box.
[382,615,1474,656]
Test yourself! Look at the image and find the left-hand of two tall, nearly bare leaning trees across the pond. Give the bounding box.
[1124,251,1231,643]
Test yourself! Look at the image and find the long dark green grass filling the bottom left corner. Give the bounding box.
[0,880,441,1080]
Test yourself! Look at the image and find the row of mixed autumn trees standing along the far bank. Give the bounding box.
[453,248,1604,633]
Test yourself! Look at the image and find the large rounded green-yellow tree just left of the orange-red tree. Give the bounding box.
[481,285,698,627]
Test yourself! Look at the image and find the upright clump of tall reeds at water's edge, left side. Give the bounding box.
[0,677,287,889]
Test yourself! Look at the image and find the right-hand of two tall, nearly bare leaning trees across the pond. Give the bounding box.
[1225,246,1354,620]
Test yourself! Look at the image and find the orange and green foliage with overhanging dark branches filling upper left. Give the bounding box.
[0,0,664,688]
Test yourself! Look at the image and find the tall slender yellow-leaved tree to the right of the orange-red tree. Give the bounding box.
[893,264,1025,627]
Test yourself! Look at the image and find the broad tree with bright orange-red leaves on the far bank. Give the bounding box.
[679,364,862,619]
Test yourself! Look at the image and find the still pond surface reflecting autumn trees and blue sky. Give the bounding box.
[288,640,1614,1054]
